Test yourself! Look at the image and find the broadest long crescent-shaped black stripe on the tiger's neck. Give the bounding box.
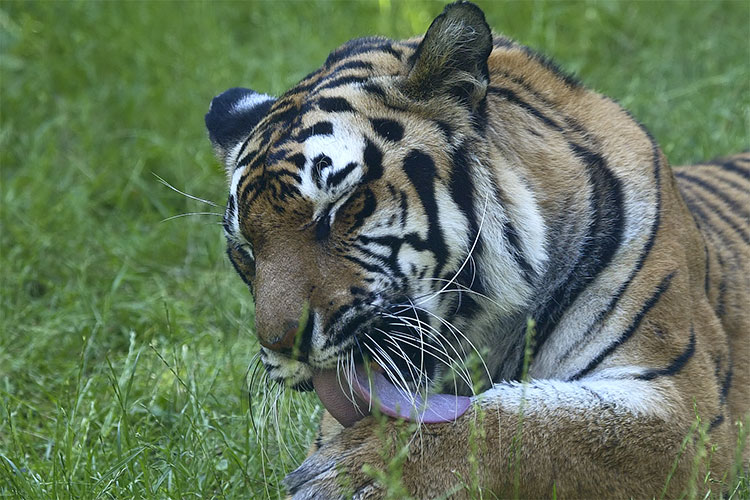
[534,144,625,354]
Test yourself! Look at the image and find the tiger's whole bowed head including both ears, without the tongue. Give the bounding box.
[206,3,544,406]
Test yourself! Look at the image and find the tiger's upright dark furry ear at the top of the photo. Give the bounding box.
[403,2,492,107]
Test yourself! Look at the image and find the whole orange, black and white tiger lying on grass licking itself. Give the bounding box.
[205,2,750,499]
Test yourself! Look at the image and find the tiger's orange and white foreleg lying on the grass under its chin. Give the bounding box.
[286,377,731,499]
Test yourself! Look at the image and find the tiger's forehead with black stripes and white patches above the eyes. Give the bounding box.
[230,83,406,212]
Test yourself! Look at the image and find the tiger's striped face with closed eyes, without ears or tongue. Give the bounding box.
[217,85,471,387]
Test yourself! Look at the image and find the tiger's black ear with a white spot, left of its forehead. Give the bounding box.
[206,87,276,171]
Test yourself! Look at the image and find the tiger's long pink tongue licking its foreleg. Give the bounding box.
[313,364,471,427]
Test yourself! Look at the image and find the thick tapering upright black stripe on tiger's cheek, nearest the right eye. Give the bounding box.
[403,149,448,276]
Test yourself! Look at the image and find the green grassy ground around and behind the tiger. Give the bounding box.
[0,0,750,498]
